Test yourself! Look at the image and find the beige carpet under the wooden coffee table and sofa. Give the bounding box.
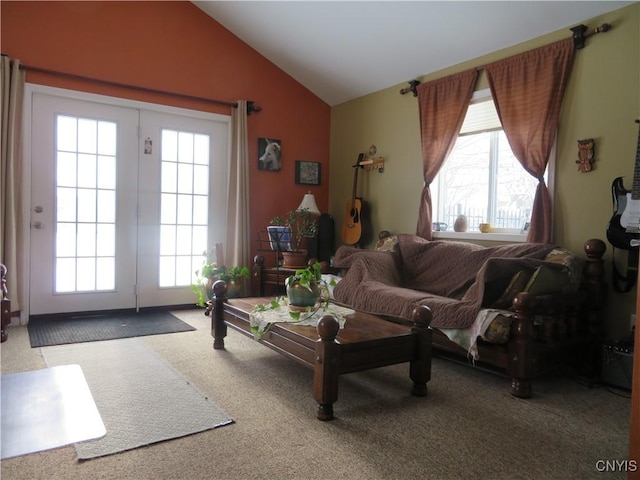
[0,311,630,480]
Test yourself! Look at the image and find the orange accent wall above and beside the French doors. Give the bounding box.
[0,1,330,264]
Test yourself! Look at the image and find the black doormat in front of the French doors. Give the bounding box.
[27,311,195,348]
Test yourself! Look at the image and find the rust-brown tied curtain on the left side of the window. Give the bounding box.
[416,69,478,240]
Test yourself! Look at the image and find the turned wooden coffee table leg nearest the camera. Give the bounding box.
[313,315,340,420]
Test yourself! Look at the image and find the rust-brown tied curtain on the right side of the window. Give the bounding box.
[485,38,574,243]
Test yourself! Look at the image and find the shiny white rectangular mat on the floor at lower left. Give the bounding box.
[1,365,105,459]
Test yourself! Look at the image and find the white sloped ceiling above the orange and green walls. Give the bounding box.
[193,0,636,106]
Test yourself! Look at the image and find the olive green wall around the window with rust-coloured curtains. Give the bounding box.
[329,3,640,339]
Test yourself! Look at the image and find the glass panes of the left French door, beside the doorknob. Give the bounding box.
[55,115,118,293]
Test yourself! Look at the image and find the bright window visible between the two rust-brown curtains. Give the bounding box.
[431,90,552,233]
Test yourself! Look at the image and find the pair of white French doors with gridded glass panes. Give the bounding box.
[29,93,229,315]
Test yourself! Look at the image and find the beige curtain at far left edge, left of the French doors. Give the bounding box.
[0,55,25,312]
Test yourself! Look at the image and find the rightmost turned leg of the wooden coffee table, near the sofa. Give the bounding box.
[409,305,433,397]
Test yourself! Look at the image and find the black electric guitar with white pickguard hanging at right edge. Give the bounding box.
[607,120,640,250]
